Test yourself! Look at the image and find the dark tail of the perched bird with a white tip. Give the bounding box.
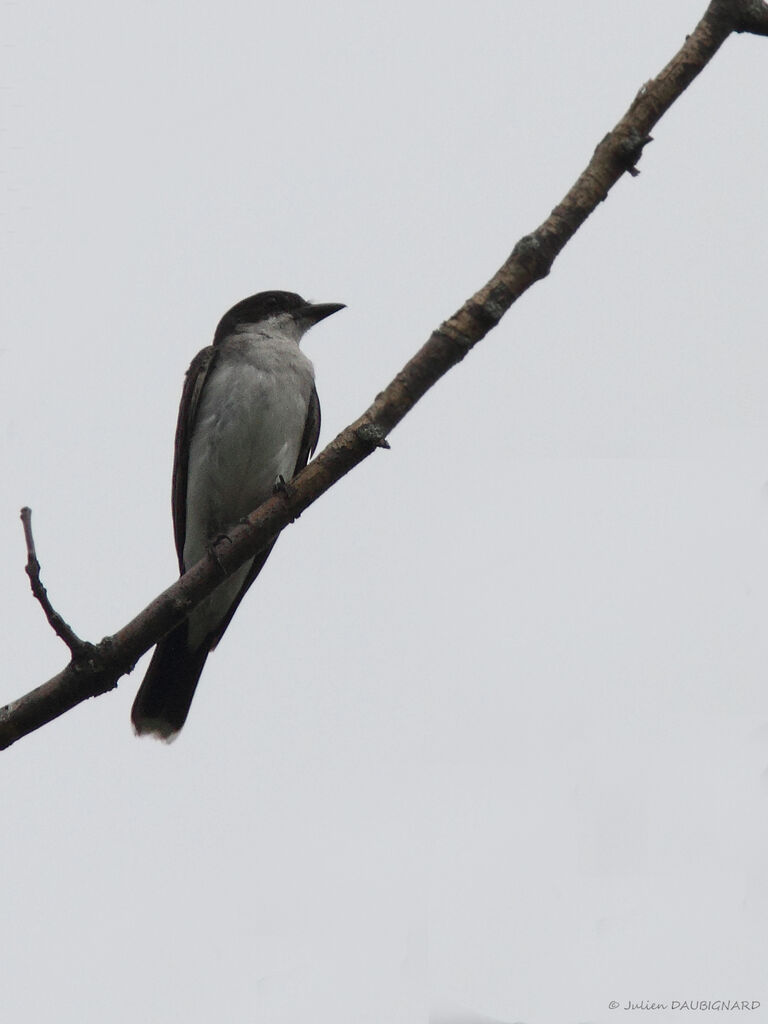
[131,623,210,740]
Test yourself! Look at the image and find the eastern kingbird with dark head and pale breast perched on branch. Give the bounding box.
[131,292,344,739]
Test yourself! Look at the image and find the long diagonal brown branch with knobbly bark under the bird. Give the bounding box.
[0,0,768,750]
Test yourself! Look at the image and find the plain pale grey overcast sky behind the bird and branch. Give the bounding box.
[0,0,768,1024]
